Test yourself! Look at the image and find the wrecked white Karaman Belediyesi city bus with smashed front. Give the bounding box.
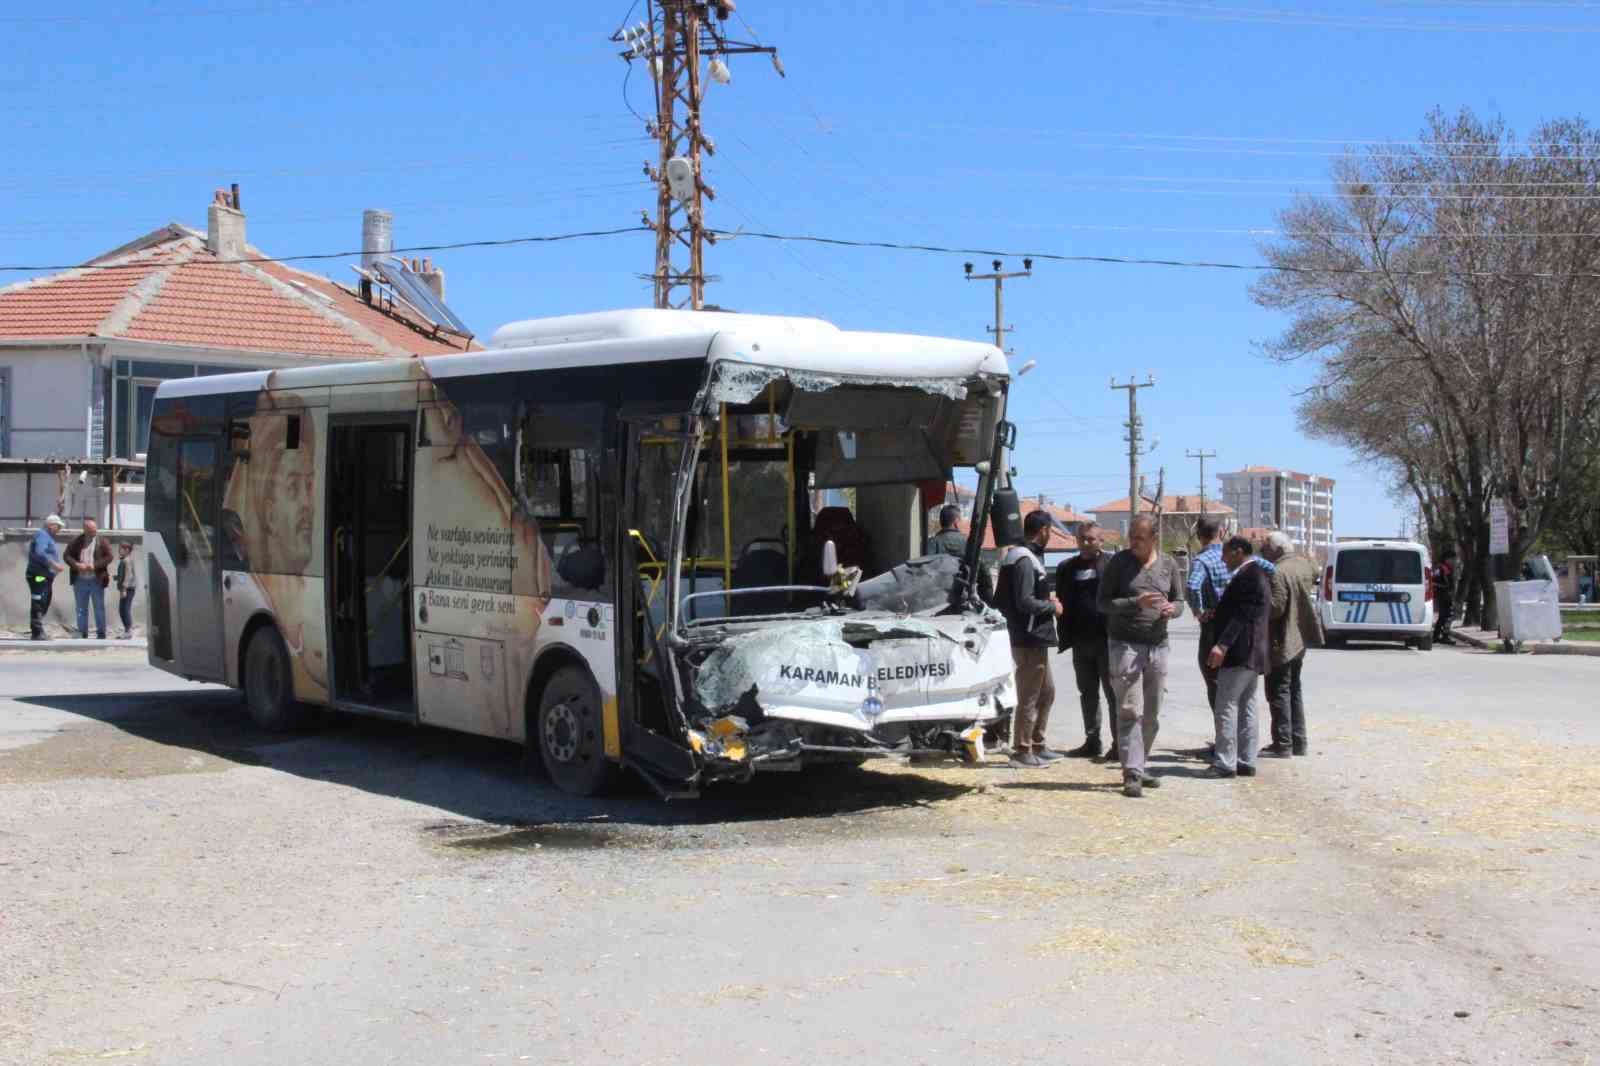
[146,311,1014,795]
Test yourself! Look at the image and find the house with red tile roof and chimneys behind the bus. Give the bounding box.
[0,187,478,528]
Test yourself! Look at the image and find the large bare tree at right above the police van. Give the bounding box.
[1253,112,1600,624]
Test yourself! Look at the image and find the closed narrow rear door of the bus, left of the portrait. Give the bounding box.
[173,437,222,680]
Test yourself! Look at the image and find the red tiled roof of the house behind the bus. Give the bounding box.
[0,224,477,359]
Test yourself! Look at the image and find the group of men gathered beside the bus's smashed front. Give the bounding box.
[995,511,1322,797]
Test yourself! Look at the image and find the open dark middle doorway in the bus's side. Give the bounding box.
[326,418,416,719]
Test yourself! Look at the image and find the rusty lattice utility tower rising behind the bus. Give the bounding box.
[611,0,784,311]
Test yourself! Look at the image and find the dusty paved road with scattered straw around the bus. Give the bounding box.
[0,617,1600,1066]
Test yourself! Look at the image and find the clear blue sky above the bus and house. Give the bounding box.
[0,0,1600,535]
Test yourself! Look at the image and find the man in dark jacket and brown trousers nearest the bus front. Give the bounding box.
[995,511,1061,768]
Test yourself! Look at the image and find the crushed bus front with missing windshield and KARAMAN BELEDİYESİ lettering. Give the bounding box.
[629,335,1014,786]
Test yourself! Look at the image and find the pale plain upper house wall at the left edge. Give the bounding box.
[0,347,90,451]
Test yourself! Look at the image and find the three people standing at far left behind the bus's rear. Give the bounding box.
[24,514,139,640]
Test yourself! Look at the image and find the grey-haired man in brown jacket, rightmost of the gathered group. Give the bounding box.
[1261,531,1322,759]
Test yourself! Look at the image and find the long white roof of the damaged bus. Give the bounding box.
[160,309,1011,397]
